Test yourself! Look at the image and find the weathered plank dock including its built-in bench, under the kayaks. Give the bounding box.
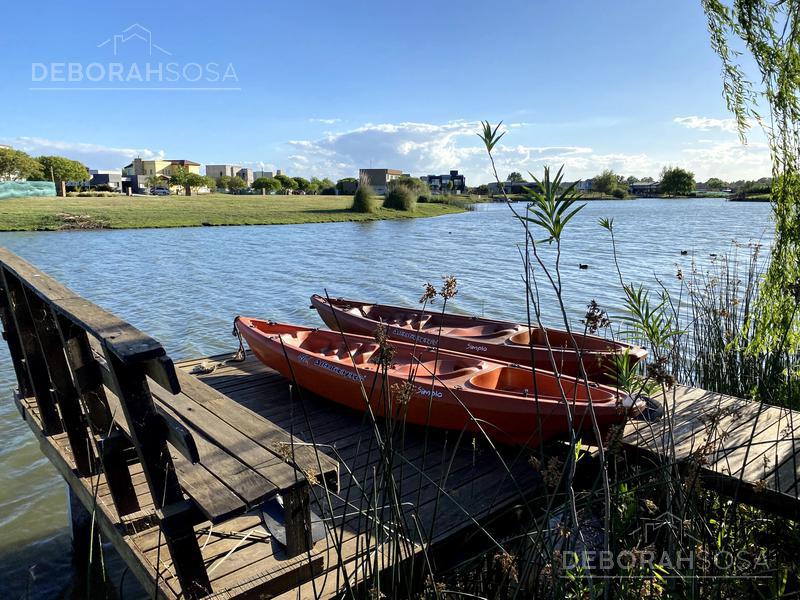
[0,250,800,600]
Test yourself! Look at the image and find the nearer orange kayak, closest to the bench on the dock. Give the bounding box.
[235,317,641,446]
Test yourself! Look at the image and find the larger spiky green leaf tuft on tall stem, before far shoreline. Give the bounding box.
[523,167,586,243]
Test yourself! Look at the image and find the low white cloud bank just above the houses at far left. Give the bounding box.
[0,136,165,169]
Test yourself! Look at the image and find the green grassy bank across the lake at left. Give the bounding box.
[0,194,463,231]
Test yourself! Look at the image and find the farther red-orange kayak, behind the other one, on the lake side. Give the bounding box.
[311,294,647,384]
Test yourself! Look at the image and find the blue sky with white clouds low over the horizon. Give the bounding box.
[0,0,770,185]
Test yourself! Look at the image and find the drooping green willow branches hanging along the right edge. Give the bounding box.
[703,0,800,355]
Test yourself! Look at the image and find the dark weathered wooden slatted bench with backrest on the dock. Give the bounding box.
[0,249,338,597]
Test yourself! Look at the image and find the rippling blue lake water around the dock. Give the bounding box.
[0,199,772,598]
